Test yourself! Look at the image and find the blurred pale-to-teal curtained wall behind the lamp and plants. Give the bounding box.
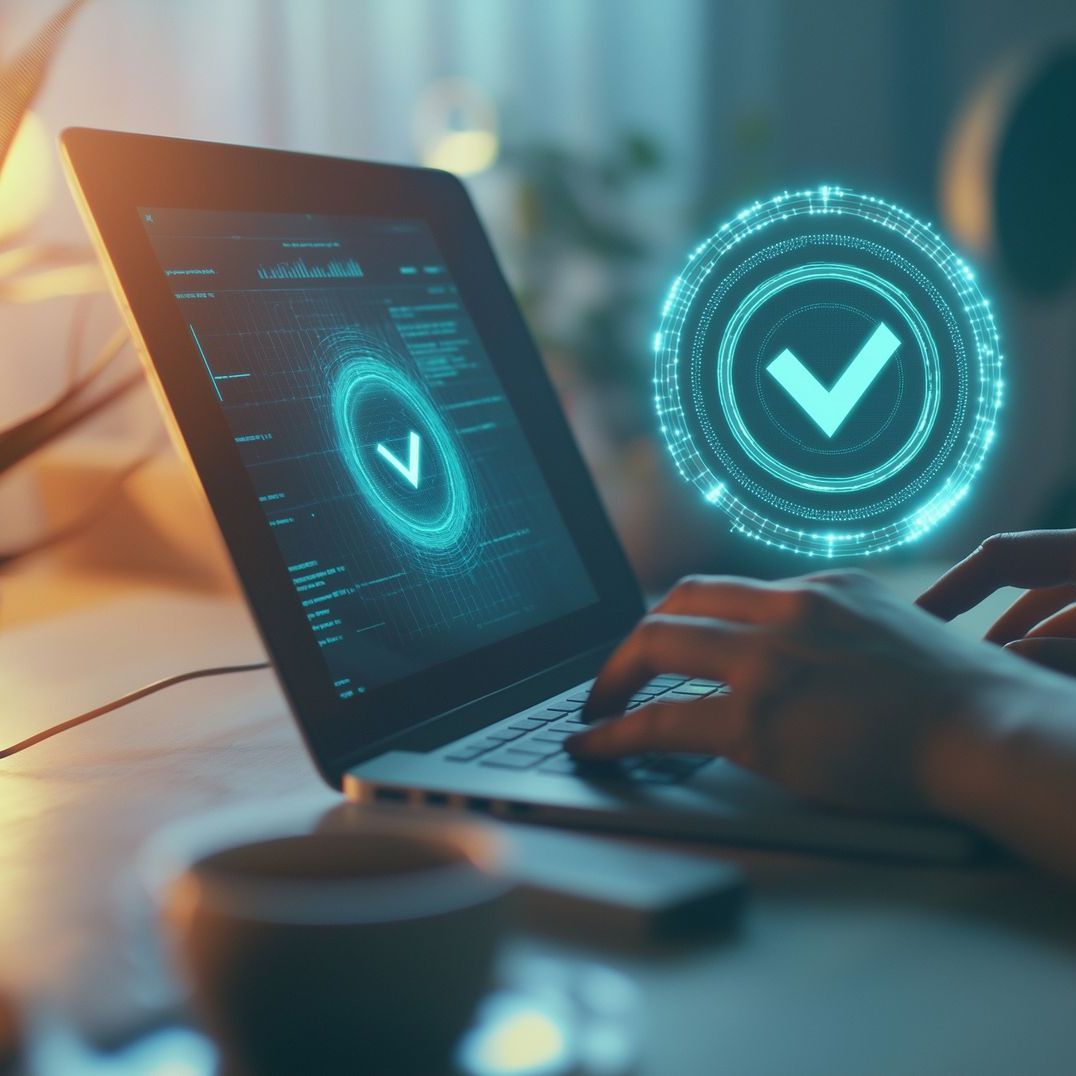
[0,0,1076,569]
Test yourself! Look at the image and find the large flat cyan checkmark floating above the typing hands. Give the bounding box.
[766,322,901,437]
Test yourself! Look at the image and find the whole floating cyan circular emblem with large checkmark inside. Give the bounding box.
[653,185,1003,558]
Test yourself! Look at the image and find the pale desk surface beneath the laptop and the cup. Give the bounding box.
[0,576,1076,1076]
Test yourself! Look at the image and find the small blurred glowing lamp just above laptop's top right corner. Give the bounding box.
[414,79,500,175]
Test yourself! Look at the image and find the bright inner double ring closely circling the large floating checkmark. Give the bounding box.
[718,264,942,493]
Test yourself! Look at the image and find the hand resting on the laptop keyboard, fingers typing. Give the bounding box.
[567,571,1028,812]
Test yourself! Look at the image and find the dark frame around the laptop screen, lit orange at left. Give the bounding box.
[61,128,643,785]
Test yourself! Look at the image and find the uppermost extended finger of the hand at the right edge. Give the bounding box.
[917,530,1076,620]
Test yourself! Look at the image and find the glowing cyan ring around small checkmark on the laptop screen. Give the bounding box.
[330,353,473,556]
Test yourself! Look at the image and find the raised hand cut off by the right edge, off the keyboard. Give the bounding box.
[917,530,1076,675]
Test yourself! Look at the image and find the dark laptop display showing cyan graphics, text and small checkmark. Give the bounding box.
[139,207,597,698]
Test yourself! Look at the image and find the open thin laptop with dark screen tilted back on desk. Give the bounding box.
[61,129,976,860]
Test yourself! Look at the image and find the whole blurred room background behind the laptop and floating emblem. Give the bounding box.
[0,0,1076,589]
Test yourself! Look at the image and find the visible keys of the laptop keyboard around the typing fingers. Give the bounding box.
[444,676,728,784]
